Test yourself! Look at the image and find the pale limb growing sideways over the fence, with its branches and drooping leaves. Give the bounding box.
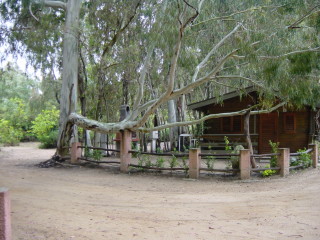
[69,1,319,137]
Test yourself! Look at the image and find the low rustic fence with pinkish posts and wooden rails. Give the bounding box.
[71,131,318,179]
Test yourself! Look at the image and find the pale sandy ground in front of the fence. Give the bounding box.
[0,143,320,240]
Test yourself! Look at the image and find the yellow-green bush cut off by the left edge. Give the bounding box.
[0,119,23,146]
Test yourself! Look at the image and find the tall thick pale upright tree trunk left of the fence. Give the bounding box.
[57,0,82,157]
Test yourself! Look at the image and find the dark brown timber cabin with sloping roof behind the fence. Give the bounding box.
[188,87,316,154]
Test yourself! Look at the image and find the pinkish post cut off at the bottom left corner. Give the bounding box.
[0,188,11,240]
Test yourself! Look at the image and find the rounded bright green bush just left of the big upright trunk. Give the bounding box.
[32,108,59,148]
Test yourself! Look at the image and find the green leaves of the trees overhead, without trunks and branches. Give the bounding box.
[0,0,320,141]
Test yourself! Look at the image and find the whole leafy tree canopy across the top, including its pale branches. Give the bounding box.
[0,0,320,152]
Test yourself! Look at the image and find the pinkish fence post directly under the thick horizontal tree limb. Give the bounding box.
[120,130,132,173]
